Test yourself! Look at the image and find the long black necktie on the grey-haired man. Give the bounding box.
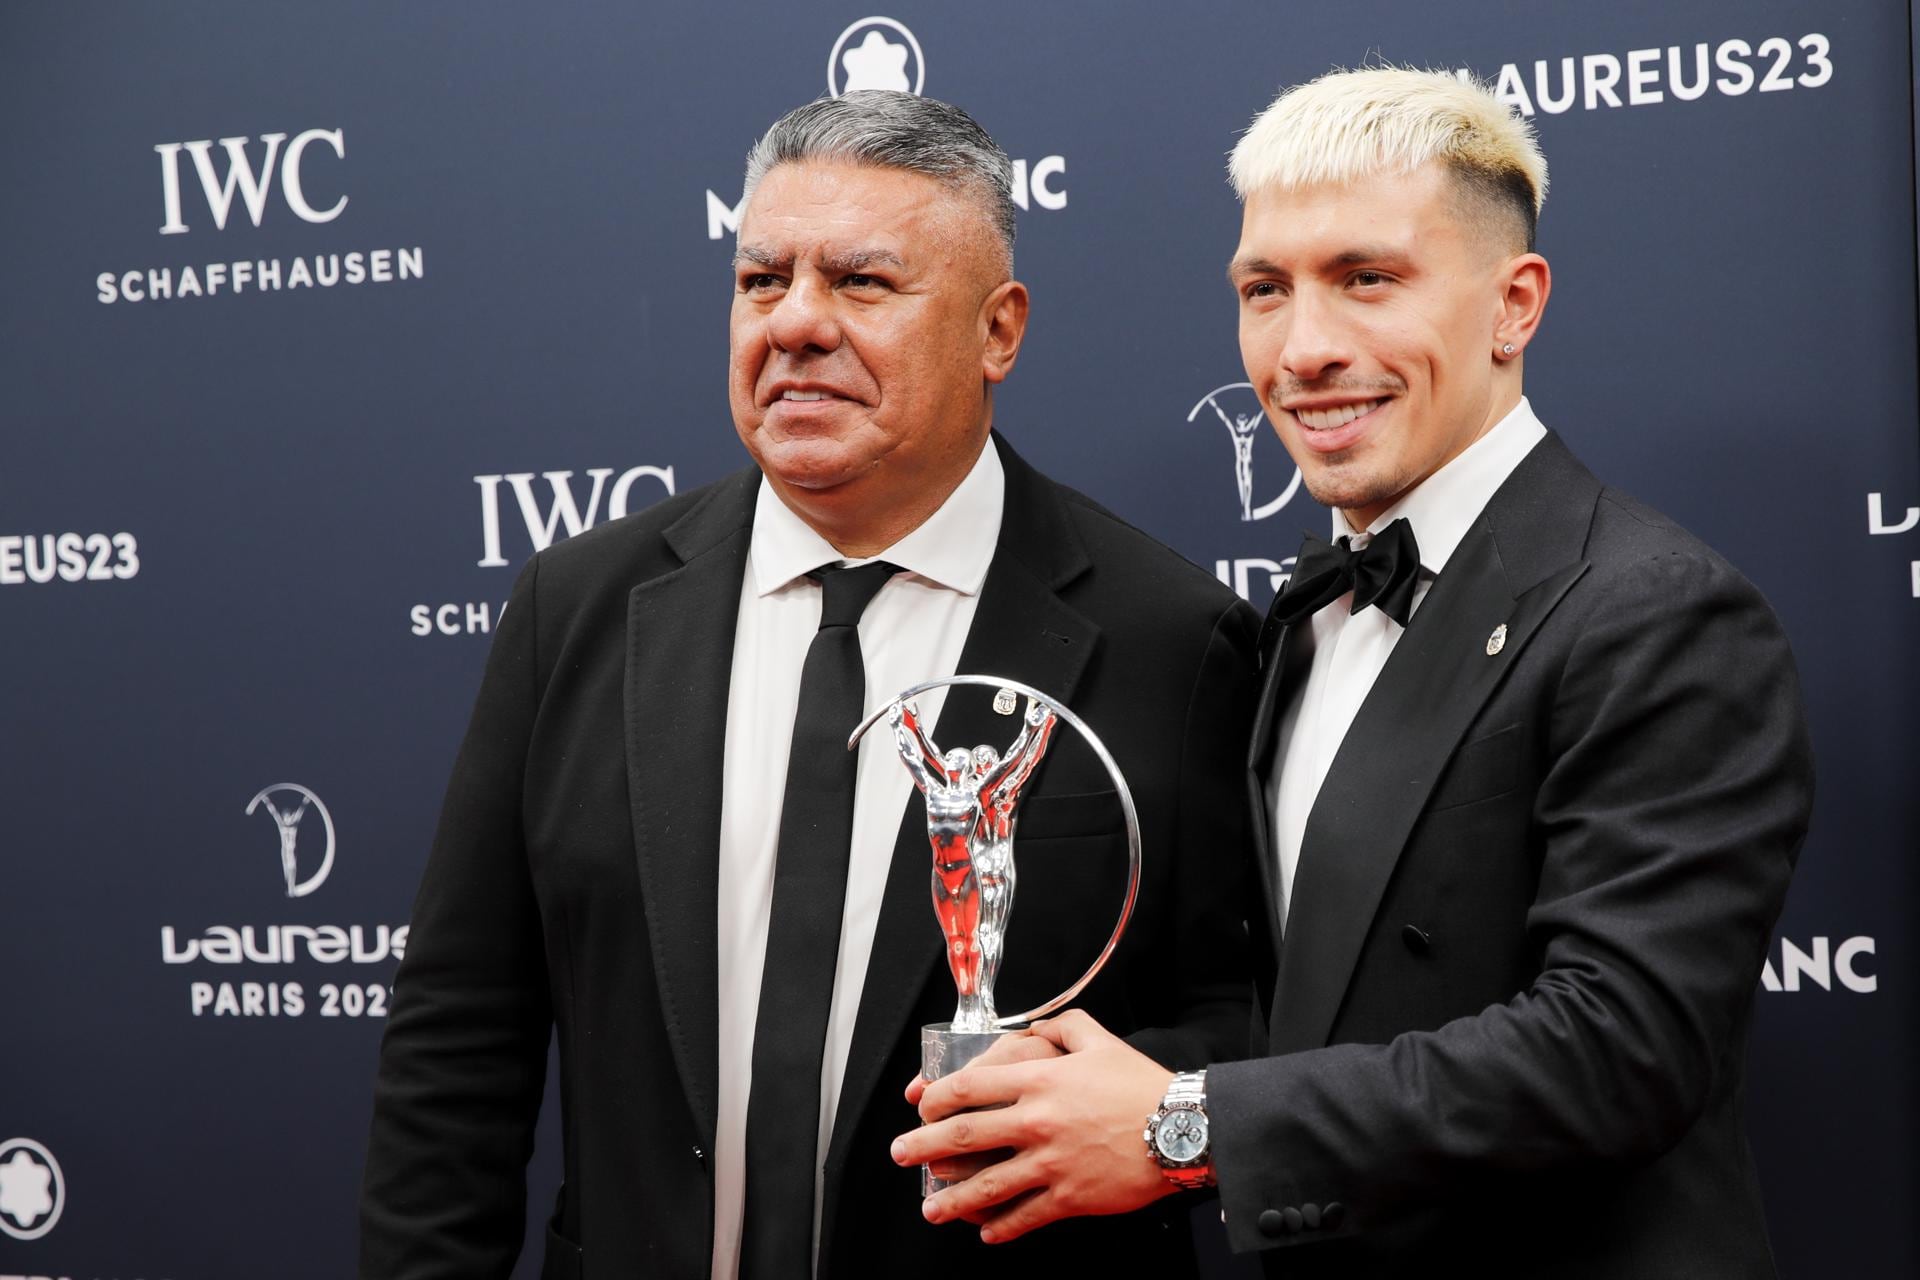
[739,560,900,1280]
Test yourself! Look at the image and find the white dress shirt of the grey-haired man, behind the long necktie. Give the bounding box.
[712,443,1006,1280]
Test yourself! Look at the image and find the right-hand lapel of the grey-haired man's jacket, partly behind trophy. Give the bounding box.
[824,434,1100,1182]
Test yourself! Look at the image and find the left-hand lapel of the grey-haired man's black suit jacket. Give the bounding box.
[624,472,758,1148]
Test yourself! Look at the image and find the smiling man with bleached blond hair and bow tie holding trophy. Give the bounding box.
[897,69,1812,1280]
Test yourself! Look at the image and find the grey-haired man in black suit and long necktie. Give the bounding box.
[361,92,1258,1280]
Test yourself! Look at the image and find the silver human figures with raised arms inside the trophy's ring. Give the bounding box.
[887,700,1054,1032]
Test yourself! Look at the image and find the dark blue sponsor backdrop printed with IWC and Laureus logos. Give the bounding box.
[0,0,1920,1280]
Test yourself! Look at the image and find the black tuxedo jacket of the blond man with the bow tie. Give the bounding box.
[1208,436,1812,1280]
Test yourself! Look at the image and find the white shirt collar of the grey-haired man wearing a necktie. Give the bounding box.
[749,441,1006,595]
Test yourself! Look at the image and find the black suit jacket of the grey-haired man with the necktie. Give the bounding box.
[361,436,1258,1280]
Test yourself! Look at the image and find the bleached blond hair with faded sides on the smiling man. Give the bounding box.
[1227,67,1548,249]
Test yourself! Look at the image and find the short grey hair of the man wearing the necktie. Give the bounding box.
[741,88,1014,274]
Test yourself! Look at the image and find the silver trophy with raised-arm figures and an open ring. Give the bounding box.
[847,676,1140,1196]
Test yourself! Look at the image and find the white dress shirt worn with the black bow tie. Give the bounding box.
[1267,397,1548,929]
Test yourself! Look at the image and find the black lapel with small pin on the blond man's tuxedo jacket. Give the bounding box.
[1269,436,1599,1054]
